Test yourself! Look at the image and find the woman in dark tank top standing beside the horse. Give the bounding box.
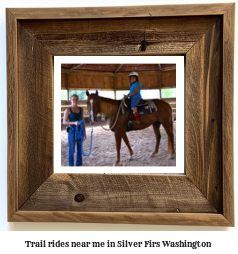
[63,94,86,166]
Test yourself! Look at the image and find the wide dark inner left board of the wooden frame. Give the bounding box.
[17,24,54,207]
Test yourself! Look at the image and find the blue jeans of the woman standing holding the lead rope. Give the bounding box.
[68,130,83,166]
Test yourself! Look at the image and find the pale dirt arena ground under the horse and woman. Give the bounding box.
[61,121,176,167]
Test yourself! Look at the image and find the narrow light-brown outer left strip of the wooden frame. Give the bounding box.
[6,10,19,220]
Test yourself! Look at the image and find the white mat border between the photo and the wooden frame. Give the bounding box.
[54,56,184,174]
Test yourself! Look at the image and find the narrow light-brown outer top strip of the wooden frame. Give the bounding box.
[9,3,232,20]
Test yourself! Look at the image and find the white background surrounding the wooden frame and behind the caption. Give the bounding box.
[0,0,238,253]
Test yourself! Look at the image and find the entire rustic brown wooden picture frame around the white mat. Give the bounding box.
[6,3,235,226]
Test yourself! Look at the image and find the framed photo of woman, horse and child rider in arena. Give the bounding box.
[55,58,184,173]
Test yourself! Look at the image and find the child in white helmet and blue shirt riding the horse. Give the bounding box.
[126,71,141,124]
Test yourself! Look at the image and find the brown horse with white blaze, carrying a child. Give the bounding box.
[86,91,175,165]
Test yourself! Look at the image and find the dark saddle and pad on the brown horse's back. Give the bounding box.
[121,98,157,115]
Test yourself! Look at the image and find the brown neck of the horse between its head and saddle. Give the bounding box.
[98,96,121,119]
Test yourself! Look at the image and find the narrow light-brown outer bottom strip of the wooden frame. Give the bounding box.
[12,211,232,227]
